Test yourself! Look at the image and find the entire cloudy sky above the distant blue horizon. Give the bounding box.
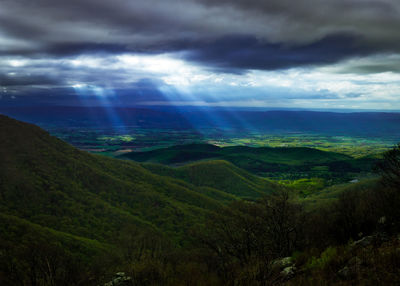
[0,0,400,110]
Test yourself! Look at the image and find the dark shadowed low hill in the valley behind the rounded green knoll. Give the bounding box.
[120,144,378,183]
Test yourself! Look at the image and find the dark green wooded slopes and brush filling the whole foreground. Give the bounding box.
[0,116,400,286]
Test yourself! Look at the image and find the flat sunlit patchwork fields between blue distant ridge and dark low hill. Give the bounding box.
[48,128,397,157]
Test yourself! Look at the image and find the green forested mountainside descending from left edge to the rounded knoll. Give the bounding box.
[0,115,279,248]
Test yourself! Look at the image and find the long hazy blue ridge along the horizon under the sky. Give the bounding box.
[0,106,400,137]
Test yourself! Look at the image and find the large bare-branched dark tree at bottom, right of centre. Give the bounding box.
[200,191,303,285]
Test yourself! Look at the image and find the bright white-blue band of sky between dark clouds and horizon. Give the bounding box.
[0,53,400,109]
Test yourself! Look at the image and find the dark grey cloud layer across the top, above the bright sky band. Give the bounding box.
[0,0,400,71]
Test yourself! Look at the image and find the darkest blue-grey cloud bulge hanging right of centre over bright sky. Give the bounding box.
[187,35,373,71]
